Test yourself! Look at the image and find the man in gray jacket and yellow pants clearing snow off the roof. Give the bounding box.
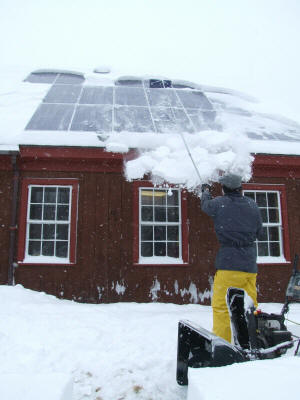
[201,174,262,342]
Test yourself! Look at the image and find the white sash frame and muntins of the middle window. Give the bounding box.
[138,186,183,264]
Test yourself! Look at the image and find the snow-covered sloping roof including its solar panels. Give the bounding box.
[0,67,300,152]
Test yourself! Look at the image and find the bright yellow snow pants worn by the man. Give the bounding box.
[212,270,257,342]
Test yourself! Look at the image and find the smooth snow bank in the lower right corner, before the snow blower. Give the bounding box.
[187,357,299,400]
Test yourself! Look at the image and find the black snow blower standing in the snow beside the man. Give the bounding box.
[177,255,300,385]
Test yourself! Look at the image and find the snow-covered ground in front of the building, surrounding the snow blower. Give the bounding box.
[0,285,300,400]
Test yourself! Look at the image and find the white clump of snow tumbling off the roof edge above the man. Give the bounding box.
[125,131,253,189]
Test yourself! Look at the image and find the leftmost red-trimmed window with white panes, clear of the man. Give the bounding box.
[18,179,78,264]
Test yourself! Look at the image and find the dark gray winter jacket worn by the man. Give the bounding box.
[201,191,262,273]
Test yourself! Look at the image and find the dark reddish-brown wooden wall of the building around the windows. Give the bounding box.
[0,148,300,304]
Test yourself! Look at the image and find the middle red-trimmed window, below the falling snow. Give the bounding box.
[135,185,187,264]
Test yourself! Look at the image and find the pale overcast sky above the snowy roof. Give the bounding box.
[0,0,300,121]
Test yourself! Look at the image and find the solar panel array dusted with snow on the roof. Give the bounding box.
[26,72,216,133]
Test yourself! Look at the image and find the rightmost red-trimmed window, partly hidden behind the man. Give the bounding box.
[244,185,290,263]
